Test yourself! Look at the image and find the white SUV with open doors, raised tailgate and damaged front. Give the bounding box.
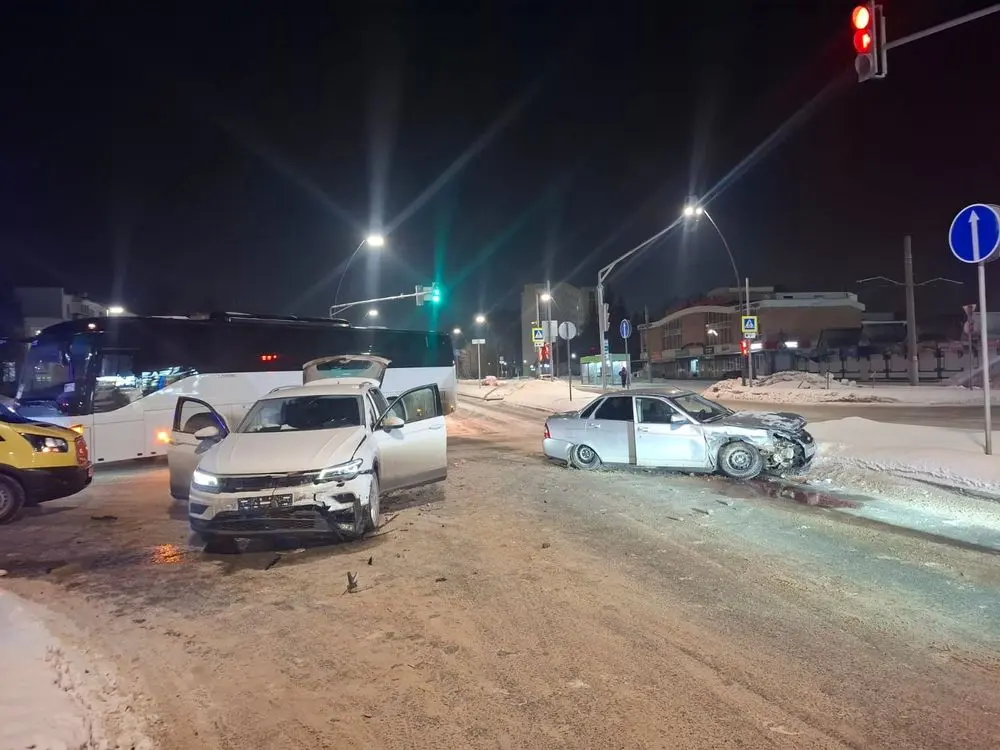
[168,357,448,548]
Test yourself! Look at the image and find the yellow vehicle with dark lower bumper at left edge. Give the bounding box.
[0,401,94,524]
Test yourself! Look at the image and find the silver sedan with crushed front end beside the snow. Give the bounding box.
[543,389,816,479]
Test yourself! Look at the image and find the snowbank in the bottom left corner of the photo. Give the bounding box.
[0,591,153,750]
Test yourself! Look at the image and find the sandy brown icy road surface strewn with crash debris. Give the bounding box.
[0,405,1000,750]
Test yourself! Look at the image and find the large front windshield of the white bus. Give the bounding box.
[18,336,93,414]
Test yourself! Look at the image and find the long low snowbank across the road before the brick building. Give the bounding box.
[704,371,1000,406]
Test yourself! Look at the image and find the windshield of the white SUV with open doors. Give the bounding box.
[236,396,362,432]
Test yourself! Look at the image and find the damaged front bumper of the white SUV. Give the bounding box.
[188,474,372,538]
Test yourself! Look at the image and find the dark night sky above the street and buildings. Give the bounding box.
[0,0,1000,328]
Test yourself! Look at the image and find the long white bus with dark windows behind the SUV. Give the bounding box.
[17,313,457,463]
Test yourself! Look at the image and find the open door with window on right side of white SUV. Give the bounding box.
[373,384,448,491]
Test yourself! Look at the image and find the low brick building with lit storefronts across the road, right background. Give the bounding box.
[642,287,865,378]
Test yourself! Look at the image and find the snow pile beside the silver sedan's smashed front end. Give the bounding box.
[807,417,1000,500]
